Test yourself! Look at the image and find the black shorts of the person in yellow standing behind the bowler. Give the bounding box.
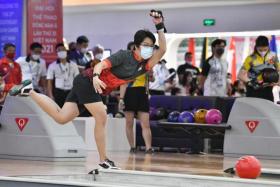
[124,87,150,112]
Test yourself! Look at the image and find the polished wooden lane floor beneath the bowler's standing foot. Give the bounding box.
[0,152,280,180]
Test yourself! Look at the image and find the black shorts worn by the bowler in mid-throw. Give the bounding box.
[66,74,102,112]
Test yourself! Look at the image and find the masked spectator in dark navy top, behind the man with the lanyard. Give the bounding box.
[69,36,91,71]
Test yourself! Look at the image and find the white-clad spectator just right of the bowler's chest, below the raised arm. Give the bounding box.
[149,59,169,95]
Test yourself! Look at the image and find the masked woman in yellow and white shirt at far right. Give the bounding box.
[238,36,280,102]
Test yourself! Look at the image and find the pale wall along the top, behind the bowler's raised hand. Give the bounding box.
[63,3,280,52]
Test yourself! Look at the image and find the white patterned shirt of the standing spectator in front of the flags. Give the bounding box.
[203,57,228,96]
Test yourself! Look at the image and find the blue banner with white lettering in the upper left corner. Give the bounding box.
[0,0,23,57]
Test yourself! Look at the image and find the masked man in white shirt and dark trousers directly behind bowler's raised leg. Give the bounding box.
[47,43,79,107]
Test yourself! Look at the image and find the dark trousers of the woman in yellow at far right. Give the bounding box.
[246,86,274,102]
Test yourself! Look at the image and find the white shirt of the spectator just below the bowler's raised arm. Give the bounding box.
[150,63,169,91]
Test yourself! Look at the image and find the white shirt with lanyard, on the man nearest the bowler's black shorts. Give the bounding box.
[47,61,79,90]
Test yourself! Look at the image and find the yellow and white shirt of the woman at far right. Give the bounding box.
[242,52,280,80]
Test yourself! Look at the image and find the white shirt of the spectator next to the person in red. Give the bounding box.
[16,56,47,90]
